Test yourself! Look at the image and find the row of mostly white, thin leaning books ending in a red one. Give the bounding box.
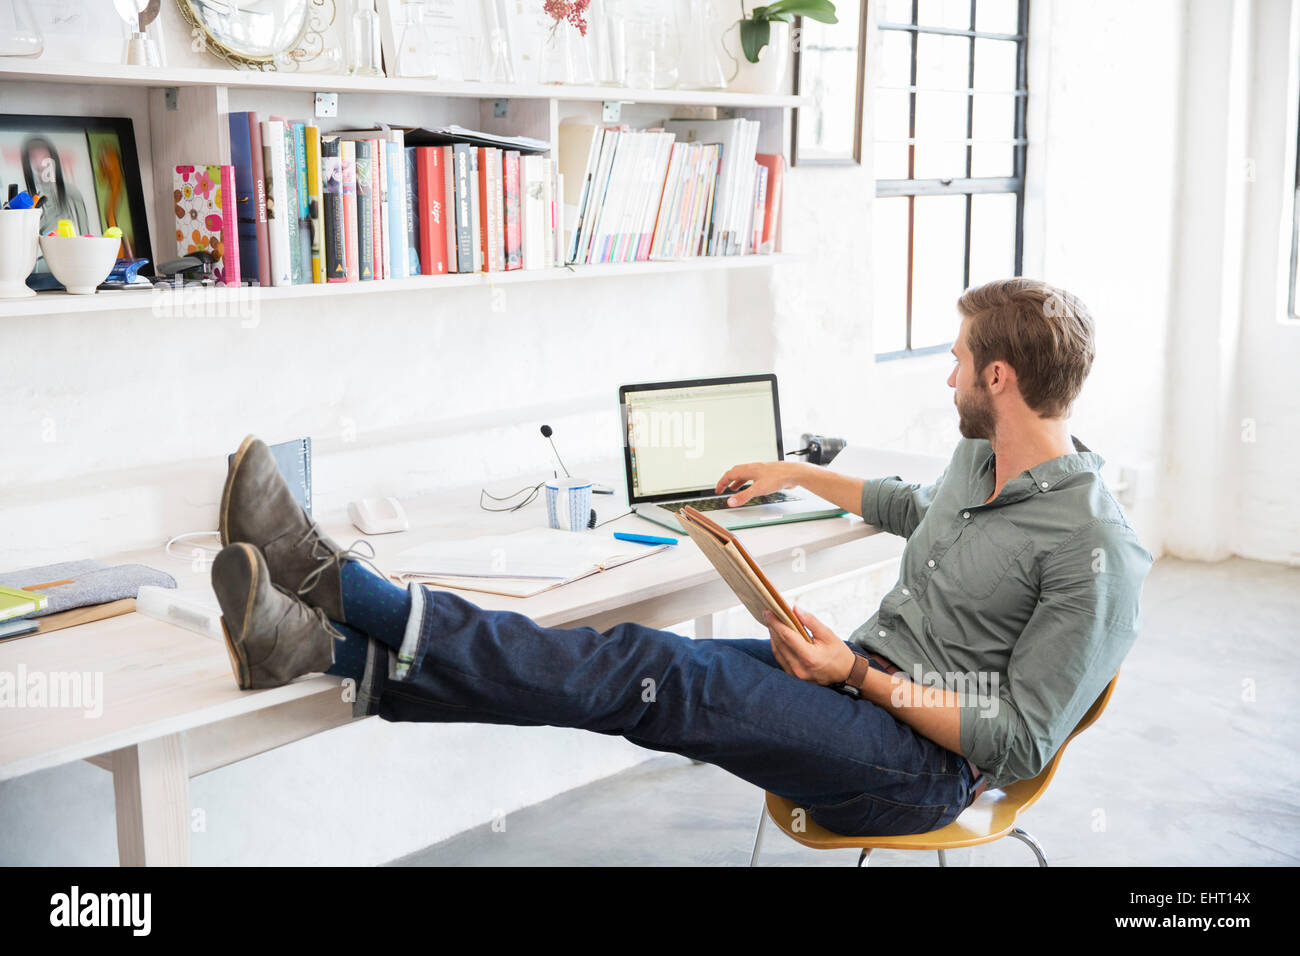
[560,118,785,263]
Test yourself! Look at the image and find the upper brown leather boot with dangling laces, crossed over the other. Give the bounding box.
[218,434,351,624]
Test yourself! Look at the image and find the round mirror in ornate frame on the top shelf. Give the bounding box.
[177,0,309,68]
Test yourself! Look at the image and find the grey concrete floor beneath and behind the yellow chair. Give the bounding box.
[394,558,1300,866]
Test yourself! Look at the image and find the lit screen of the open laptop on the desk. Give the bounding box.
[619,375,781,505]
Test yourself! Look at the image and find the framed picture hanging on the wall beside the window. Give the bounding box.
[790,0,867,166]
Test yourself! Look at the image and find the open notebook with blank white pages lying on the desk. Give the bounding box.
[393,528,670,597]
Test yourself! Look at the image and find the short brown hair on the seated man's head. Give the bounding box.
[957,278,1096,418]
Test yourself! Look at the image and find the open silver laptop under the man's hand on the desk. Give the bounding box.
[619,375,844,533]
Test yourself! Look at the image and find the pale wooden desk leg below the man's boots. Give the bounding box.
[112,734,190,866]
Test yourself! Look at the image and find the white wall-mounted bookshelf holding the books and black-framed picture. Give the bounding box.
[0,57,805,319]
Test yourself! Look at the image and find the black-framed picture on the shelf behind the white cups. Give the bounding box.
[0,113,153,290]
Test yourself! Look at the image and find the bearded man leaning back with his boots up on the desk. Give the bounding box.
[212,278,1152,835]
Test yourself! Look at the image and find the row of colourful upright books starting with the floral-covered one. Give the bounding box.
[174,111,560,286]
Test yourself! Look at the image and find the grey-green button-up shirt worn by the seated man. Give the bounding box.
[849,438,1152,787]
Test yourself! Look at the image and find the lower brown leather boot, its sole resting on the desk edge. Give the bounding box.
[212,542,345,691]
